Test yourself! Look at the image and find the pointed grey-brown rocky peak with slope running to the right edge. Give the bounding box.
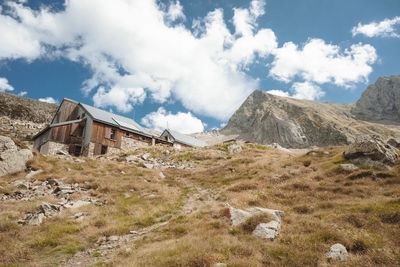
[221,76,400,148]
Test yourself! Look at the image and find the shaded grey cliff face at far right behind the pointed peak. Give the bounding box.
[352,75,400,125]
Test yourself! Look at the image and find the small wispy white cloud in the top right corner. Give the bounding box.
[351,17,400,38]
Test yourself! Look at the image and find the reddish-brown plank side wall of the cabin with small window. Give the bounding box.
[90,122,125,148]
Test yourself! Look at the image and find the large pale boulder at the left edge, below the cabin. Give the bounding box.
[0,136,33,176]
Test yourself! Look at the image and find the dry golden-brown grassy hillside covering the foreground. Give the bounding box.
[0,144,400,266]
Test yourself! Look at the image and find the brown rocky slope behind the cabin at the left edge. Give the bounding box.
[0,92,58,139]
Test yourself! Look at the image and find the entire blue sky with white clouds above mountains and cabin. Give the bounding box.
[0,0,400,133]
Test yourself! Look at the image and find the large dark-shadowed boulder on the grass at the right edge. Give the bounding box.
[343,136,398,169]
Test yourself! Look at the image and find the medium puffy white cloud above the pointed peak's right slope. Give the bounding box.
[269,39,377,87]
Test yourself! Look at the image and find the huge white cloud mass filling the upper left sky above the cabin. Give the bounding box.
[0,0,277,120]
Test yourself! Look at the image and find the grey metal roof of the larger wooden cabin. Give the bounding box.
[79,103,152,137]
